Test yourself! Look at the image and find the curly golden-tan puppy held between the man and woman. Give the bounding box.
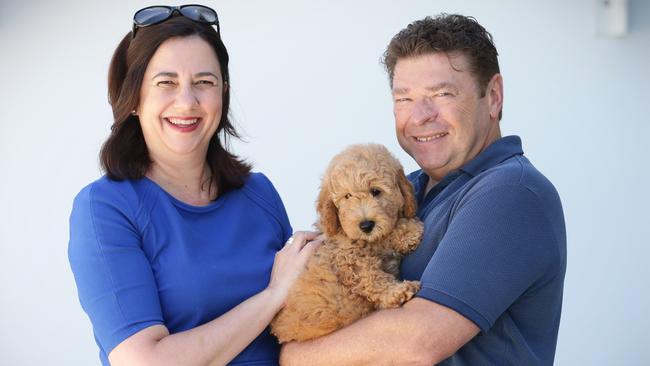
[271,144,423,343]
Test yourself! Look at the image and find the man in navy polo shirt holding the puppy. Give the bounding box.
[281,14,566,365]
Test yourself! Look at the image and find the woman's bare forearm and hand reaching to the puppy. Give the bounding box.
[109,232,322,366]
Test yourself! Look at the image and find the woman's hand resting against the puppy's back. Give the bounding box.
[267,231,324,307]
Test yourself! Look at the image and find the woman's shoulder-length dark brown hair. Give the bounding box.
[100,16,251,195]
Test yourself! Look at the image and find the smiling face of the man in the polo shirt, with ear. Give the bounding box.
[392,52,503,181]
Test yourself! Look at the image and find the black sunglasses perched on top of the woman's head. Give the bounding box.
[131,4,220,37]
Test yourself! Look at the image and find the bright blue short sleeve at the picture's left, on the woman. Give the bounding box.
[68,181,163,355]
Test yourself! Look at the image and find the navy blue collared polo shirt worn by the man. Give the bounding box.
[401,136,566,366]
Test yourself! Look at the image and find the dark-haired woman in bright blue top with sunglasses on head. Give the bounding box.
[69,5,320,365]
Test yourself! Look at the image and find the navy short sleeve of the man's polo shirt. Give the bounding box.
[417,186,559,331]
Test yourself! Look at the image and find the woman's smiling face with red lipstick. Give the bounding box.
[136,36,224,161]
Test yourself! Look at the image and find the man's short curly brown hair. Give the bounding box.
[383,13,502,120]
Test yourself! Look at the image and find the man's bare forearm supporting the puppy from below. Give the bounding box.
[280,298,479,366]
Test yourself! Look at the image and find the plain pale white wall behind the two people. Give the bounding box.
[0,0,650,365]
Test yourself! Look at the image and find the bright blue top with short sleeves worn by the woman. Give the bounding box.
[68,173,292,365]
